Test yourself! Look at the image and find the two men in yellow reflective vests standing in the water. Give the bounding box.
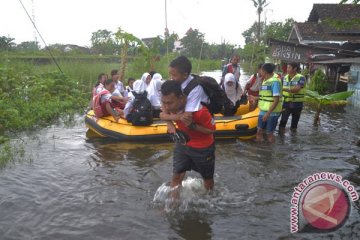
[252,62,306,143]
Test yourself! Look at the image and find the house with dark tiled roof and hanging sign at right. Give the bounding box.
[269,4,360,106]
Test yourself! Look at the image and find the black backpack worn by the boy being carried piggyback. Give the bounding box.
[183,75,226,114]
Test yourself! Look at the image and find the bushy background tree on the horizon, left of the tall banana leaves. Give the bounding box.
[91,29,119,54]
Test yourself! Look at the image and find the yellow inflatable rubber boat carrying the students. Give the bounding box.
[85,105,259,141]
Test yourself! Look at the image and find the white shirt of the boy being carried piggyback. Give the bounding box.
[181,75,210,112]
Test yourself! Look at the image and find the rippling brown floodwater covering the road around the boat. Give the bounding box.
[0,73,360,240]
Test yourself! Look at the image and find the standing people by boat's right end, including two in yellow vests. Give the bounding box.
[222,55,306,143]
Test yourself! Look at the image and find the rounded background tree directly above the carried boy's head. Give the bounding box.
[181,28,204,58]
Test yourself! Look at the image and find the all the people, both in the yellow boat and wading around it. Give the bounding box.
[93,56,305,195]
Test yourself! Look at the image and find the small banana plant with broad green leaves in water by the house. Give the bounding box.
[305,89,354,126]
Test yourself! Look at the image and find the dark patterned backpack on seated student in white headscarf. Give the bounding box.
[126,91,153,126]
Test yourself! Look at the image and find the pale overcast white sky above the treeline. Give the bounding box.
[0,0,340,46]
